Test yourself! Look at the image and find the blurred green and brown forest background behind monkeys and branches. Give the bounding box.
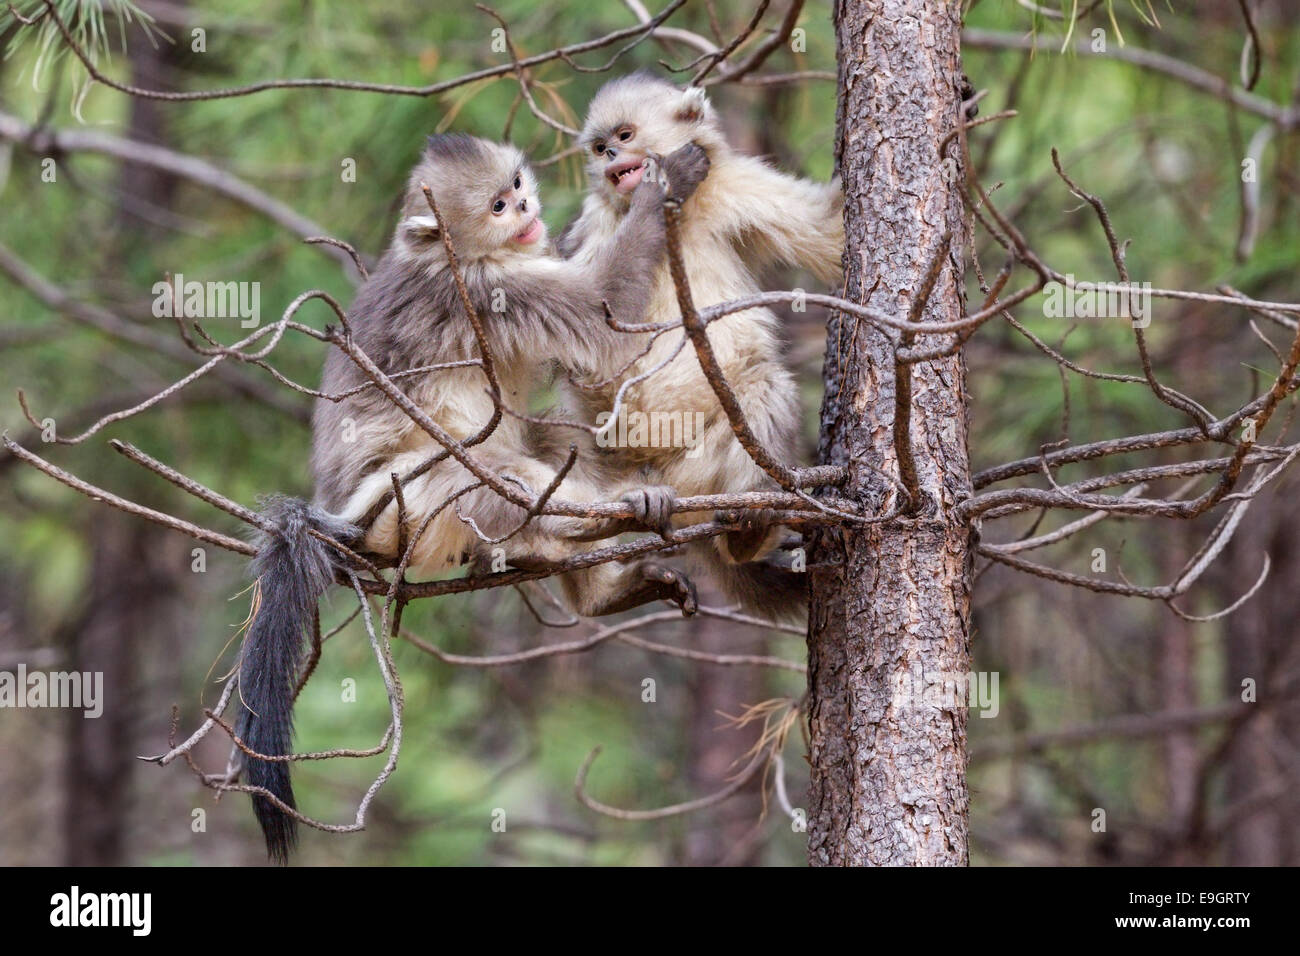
[0,0,1300,865]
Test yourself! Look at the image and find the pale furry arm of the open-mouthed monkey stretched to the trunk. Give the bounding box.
[722,156,844,284]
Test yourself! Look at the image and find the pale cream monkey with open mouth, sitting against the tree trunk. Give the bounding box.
[559,73,844,617]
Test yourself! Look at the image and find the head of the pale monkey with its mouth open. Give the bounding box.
[580,73,719,207]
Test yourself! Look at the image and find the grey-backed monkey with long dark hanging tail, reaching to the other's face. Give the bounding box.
[237,134,709,861]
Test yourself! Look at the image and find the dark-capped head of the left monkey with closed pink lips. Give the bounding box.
[399,134,546,260]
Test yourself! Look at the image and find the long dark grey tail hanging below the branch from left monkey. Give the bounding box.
[235,497,359,864]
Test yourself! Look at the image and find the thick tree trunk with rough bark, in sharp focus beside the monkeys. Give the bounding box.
[809,0,971,865]
